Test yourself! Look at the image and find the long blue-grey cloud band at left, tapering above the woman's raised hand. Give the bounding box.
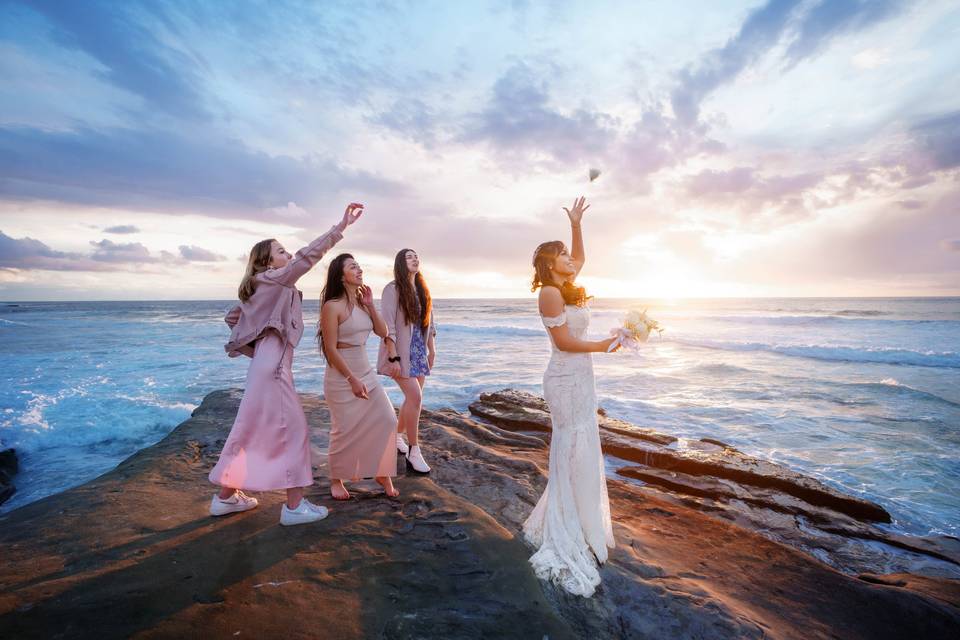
[0,127,404,219]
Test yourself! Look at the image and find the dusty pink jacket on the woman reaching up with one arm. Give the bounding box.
[224,222,344,368]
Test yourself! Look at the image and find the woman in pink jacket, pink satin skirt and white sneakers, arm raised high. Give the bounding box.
[210,203,363,525]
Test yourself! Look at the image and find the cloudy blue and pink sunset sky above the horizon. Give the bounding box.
[0,0,960,300]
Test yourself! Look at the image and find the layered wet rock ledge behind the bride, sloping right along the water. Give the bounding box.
[470,389,960,578]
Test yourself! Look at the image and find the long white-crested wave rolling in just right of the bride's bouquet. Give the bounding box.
[664,336,960,369]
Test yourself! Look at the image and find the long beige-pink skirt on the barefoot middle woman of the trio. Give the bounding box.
[323,347,397,480]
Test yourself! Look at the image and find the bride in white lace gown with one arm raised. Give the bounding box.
[523,198,614,597]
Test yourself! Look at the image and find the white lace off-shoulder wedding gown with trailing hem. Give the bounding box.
[523,305,614,597]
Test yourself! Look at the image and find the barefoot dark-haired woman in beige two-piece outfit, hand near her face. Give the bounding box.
[318,253,400,500]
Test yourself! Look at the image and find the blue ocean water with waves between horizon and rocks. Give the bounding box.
[0,298,960,536]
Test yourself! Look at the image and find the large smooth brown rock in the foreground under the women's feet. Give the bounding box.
[0,391,960,640]
